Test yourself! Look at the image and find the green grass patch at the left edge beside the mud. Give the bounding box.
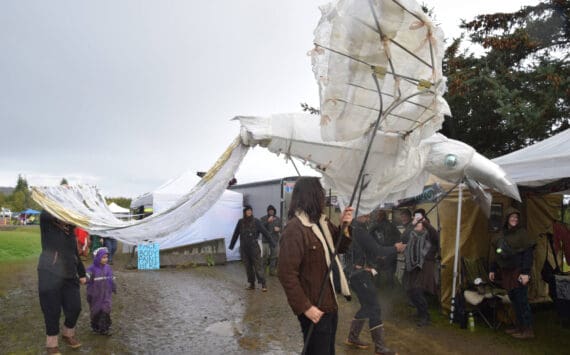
[0,226,42,262]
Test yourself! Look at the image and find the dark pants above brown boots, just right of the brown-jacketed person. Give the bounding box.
[350,270,382,328]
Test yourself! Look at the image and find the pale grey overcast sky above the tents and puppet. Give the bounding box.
[0,0,538,197]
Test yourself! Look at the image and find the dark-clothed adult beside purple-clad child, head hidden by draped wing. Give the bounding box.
[38,210,87,354]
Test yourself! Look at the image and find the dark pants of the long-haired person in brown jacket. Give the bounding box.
[298,312,338,355]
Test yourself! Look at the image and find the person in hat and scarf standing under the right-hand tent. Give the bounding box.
[489,207,536,339]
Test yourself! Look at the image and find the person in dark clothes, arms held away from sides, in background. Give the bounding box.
[230,205,275,292]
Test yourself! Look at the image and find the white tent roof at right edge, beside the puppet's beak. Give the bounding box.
[493,129,570,186]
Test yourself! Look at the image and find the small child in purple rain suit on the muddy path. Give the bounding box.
[87,247,117,335]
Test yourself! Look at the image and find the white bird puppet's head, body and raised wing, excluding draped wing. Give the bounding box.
[233,0,520,212]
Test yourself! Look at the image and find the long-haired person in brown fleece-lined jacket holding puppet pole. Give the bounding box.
[277,177,353,354]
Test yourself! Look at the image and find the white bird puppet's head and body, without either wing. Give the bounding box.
[236,113,520,213]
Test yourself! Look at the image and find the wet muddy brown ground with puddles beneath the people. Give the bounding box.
[0,258,570,355]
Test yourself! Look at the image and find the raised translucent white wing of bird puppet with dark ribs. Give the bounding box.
[310,0,450,146]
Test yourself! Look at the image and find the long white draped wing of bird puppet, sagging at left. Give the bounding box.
[32,139,248,244]
